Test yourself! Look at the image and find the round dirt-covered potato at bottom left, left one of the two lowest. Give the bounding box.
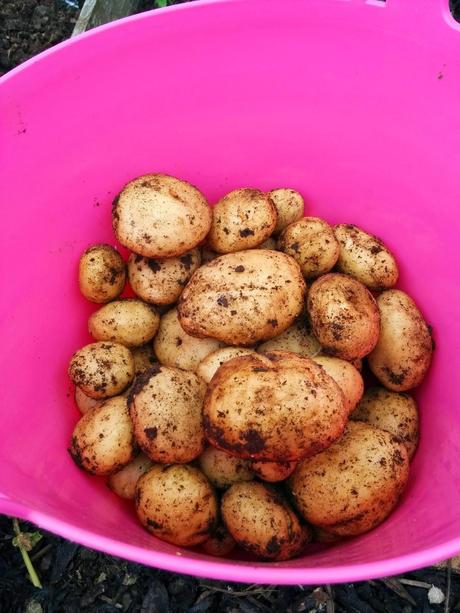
[134,464,217,547]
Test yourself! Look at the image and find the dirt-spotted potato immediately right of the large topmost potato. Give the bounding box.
[207,188,277,253]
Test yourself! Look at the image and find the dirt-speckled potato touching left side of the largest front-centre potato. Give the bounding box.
[128,364,206,464]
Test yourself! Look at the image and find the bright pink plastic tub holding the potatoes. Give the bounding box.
[0,0,460,584]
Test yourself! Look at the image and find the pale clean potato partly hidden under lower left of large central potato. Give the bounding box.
[153,309,223,370]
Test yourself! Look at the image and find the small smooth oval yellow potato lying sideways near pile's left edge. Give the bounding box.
[88,298,160,347]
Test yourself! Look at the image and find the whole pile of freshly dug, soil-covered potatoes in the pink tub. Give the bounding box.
[69,174,433,560]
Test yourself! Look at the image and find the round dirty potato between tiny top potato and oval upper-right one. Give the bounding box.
[278,217,339,279]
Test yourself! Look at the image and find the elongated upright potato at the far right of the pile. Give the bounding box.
[369,289,433,392]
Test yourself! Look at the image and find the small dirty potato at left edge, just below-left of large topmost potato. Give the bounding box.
[78,245,126,303]
